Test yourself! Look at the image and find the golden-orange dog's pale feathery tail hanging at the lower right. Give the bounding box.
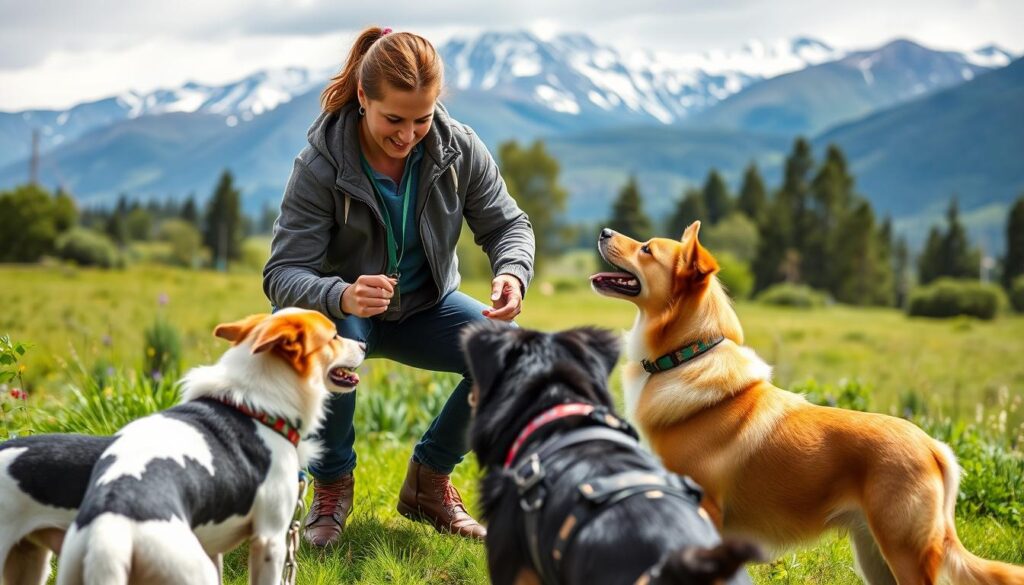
[932,441,1024,585]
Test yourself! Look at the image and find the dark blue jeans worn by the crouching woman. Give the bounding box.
[309,291,505,482]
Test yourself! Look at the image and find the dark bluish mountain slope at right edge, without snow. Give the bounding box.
[815,59,1024,216]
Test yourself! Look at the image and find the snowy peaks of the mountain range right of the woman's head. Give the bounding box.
[440,32,844,124]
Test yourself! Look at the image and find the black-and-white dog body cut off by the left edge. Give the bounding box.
[0,434,114,585]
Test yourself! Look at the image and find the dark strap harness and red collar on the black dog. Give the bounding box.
[504,403,703,585]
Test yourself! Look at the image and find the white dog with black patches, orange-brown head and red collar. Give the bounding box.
[57,308,365,585]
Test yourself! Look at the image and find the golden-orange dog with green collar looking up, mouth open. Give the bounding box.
[592,222,1024,585]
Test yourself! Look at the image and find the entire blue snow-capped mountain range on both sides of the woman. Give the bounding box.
[0,33,1014,218]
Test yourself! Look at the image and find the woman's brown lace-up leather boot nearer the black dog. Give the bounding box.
[398,459,487,540]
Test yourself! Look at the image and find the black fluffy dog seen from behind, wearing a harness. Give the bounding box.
[463,323,758,585]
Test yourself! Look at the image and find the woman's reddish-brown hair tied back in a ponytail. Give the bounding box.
[321,27,444,112]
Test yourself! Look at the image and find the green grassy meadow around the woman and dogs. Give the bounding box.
[0,265,1024,584]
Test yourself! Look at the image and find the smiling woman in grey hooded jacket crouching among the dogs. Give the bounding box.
[263,28,535,546]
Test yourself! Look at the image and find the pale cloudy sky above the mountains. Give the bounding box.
[0,0,1024,112]
